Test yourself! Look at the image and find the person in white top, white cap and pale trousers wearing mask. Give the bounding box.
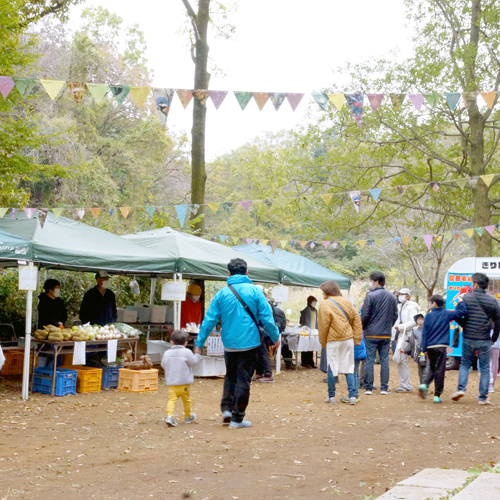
[392,288,420,392]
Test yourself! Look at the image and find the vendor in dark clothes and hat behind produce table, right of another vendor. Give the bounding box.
[80,271,118,326]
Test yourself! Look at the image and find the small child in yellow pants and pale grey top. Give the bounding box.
[161,330,201,427]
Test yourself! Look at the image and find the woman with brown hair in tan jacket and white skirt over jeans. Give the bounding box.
[318,281,363,405]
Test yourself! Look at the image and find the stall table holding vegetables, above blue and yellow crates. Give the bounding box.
[31,337,139,396]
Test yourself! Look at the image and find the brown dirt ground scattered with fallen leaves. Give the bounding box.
[0,363,500,500]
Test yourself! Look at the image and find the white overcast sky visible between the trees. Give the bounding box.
[71,0,411,160]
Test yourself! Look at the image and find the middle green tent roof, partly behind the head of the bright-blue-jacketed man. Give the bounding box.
[124,227,280,283]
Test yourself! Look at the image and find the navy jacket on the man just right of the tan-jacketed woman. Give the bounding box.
[361,286,398,338]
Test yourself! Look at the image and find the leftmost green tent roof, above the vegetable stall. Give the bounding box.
[0,212,175,275]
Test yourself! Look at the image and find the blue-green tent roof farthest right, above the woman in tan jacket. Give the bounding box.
[233,243,351,290]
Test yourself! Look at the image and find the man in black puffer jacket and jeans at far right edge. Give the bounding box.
[451,273,500,405]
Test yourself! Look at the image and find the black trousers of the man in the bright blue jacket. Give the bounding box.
[221,347,257,423]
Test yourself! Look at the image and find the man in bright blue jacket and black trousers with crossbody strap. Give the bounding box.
[194,259,279,428]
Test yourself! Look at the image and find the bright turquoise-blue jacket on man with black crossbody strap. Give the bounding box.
[196,274,279,349]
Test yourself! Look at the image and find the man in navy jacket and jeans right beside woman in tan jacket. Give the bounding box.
[361,271,398,395]
